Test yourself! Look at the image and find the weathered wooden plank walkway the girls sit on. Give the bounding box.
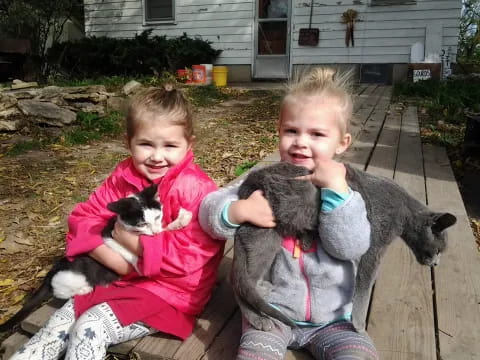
[3,85,480,360]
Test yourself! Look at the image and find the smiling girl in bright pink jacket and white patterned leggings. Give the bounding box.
[12,85,224,360]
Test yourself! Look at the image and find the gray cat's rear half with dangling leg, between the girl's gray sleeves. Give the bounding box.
[231,162,320,329]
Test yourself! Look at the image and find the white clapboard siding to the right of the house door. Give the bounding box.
[291,0,461,65]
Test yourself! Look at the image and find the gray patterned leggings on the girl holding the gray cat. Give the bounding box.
[237,321,378,360]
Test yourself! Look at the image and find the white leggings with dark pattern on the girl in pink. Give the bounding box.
[10,300,155,360]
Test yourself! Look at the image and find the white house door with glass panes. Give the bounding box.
[253,0,291,79]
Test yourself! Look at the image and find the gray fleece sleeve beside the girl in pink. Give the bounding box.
[198,182,241,239]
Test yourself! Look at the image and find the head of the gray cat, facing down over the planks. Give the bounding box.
[404,213,457,266]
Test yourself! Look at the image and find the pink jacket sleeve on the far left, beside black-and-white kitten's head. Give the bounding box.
[65,176,121,258]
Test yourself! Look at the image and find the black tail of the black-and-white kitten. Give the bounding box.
[0,258,64,332]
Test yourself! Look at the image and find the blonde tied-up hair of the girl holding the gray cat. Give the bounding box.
[281,67,353,135]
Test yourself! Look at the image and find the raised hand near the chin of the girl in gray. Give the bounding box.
[298,159,348,193]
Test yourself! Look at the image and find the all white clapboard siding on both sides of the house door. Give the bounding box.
[84,0,461,73]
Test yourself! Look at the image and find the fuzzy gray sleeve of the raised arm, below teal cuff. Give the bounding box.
[318,191,370,260]
